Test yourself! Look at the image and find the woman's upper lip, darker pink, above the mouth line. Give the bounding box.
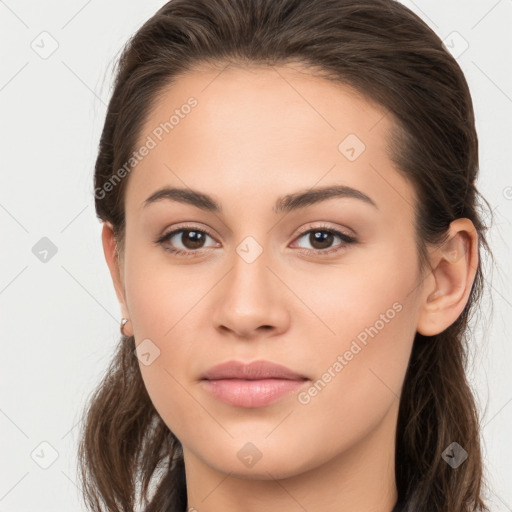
[201,360,307,380]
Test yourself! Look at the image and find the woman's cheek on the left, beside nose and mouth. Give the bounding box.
[125,247,211,436]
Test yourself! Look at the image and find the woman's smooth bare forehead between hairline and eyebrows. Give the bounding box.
[125,61,412,220]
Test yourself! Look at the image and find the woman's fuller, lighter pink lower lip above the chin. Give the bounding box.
[201,379,306,407]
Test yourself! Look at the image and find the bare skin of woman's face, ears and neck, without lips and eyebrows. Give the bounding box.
[102,63,478,512]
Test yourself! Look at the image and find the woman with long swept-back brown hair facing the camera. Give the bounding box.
[79,0,487,512]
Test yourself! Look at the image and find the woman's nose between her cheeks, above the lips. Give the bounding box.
[213,244,289,339]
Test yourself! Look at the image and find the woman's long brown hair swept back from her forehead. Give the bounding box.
[79,0,489,512]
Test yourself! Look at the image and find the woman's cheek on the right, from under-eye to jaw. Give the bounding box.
[298,241,418,424]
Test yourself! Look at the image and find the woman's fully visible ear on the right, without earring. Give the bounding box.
[416,219,478,336]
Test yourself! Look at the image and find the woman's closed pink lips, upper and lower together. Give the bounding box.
[201,361,309,408]
